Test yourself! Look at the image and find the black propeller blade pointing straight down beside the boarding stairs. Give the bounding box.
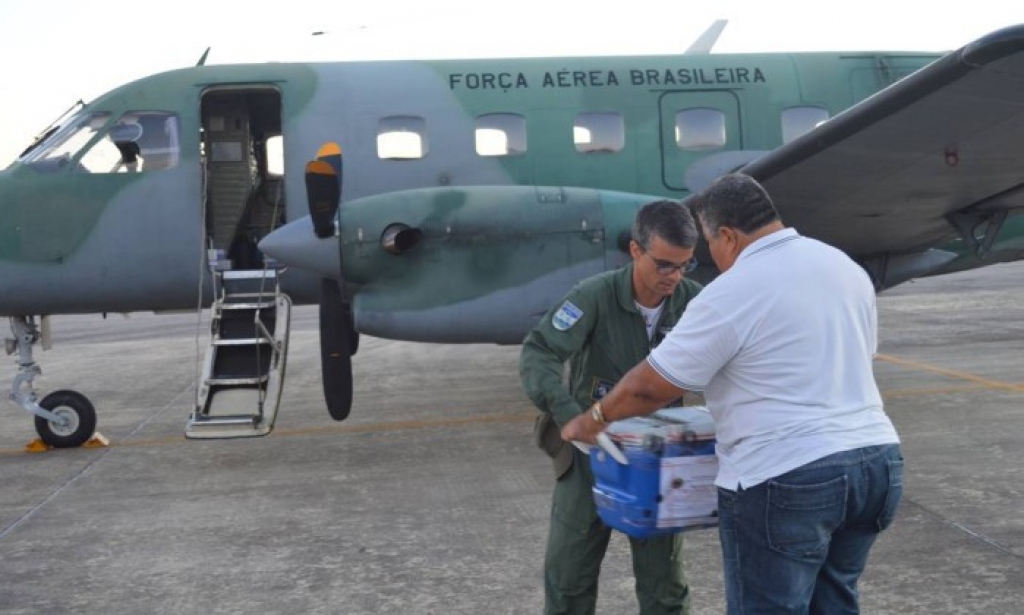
[319,279,357,421]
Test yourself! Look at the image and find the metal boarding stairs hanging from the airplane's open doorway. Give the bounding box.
[185,269,292,438]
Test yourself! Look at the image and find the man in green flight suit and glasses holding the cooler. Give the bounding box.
[519,201,701,615]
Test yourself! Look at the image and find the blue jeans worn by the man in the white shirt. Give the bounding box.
[718,444,903,615]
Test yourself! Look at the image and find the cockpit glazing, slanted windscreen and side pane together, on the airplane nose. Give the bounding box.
[24,112,180,174]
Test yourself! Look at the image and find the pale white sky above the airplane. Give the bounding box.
[0,0,1024,169]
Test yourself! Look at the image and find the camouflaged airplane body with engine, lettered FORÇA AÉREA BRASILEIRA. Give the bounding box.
[0,49,1019,343]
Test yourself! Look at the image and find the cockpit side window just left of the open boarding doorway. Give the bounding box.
[78,112,180,173]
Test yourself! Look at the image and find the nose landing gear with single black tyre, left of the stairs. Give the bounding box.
[4,316,96,448]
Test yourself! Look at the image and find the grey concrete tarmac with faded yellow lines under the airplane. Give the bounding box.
[0,263,1024,615]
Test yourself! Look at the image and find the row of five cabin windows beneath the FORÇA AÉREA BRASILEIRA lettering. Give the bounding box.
[377,106,828,160]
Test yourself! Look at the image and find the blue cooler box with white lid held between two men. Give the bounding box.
[590,406,718,538]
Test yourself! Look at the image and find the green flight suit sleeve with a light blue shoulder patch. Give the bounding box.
[519,287,597,426]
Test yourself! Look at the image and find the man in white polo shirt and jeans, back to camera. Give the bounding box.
[562,174,903,614]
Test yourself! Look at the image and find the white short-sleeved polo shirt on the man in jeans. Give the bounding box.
[647,228,899,489]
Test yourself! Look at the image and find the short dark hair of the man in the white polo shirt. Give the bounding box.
[690,173,780,235]
